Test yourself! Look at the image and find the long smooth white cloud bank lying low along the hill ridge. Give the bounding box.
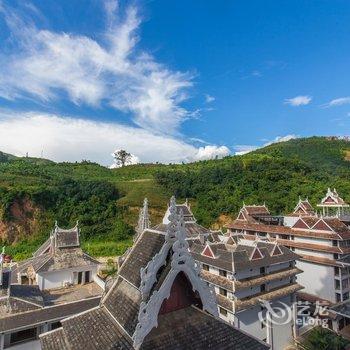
[0,110,229,165]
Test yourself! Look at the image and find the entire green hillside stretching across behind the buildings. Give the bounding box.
[0,137,350,258]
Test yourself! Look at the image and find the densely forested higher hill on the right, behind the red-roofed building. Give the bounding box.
[156,137,350,224]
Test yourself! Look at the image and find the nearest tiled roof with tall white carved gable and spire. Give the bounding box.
[41,198,268,350]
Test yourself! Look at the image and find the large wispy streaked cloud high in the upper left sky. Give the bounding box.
[0,0,192,134]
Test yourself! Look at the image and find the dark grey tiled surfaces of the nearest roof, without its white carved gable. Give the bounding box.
[41,230,268,350]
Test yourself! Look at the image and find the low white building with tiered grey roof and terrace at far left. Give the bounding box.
[0,225,104,350]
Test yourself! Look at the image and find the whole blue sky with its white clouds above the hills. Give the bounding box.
[0,0,350,164]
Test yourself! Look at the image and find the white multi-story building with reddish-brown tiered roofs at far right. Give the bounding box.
[227,191,350,303]
